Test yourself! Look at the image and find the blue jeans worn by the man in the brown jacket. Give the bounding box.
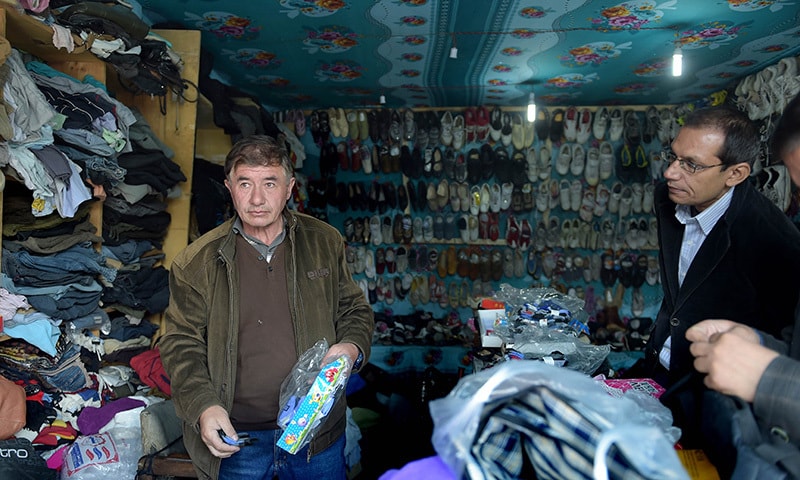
[219,429,347,480]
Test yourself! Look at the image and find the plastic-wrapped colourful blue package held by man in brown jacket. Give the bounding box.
[278,339,352,454]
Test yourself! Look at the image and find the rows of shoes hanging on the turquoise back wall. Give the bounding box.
[295,106,680,348]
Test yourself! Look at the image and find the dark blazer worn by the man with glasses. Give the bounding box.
[645,181,800,387]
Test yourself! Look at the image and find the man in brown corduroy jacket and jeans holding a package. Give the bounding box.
[159,136,374,480]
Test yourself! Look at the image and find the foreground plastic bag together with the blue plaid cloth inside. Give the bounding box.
[430,362,688,480]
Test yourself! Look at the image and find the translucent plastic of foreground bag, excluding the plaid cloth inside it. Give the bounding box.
[430,361,689,480]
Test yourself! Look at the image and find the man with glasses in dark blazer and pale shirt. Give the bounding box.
[644,107,800,447]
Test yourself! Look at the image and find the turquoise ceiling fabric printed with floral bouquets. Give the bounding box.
[141,0,800,109]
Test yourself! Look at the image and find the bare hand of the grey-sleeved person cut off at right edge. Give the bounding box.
[686,320,778,403]
